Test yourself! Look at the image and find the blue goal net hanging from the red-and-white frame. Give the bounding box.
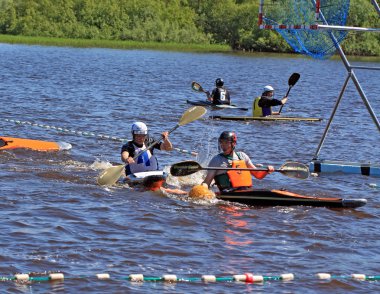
[259,0,350,59]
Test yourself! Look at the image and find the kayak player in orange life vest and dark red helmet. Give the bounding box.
[202,131,274,191]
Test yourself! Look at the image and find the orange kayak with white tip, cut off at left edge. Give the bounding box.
[0,137,71,151]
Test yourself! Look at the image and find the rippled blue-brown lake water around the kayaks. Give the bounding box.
[0,44,380,293]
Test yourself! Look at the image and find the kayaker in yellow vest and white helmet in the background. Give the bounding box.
[252,85,288,117]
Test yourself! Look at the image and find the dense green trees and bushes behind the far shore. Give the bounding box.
[0,0,380,56]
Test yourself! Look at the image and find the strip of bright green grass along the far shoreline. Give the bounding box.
[0,34,380,62]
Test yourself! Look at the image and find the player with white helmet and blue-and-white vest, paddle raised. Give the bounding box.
[121,122,173,175]
